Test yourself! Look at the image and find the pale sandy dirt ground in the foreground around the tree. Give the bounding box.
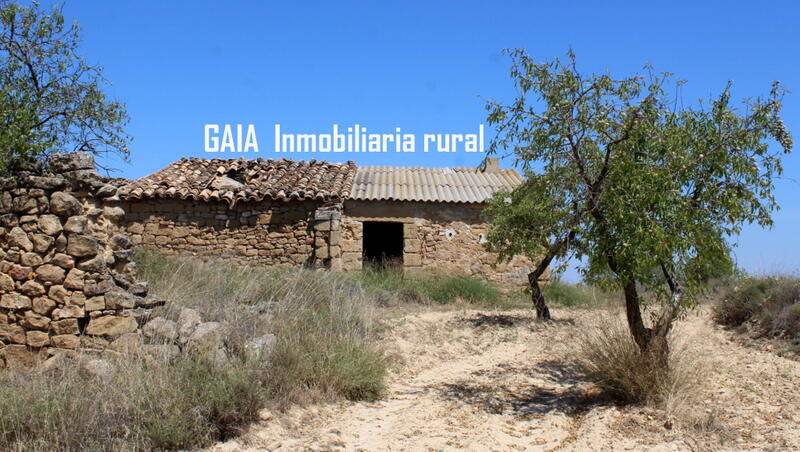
[212,309,800,452]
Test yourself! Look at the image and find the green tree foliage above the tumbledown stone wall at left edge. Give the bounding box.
[0,1,130,174]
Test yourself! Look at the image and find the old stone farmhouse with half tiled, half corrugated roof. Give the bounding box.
[112,158,530,285]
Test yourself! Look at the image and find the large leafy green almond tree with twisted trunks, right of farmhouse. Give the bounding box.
[487,50,792,355]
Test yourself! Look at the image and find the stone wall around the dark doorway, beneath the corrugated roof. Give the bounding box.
[341,201,531,286]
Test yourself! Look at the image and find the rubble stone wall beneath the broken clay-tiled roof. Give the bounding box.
[106,199,316,266]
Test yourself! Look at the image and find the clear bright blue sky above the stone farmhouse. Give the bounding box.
[36,0,800,279]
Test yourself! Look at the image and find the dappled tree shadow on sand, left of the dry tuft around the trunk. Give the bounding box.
[438,361,615,418]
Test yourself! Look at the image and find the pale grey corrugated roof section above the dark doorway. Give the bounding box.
[349,166,522,203]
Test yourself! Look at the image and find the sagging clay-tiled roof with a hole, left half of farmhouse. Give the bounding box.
[118,158,356,205]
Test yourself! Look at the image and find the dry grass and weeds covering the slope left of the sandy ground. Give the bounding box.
[0,251,386,450]
